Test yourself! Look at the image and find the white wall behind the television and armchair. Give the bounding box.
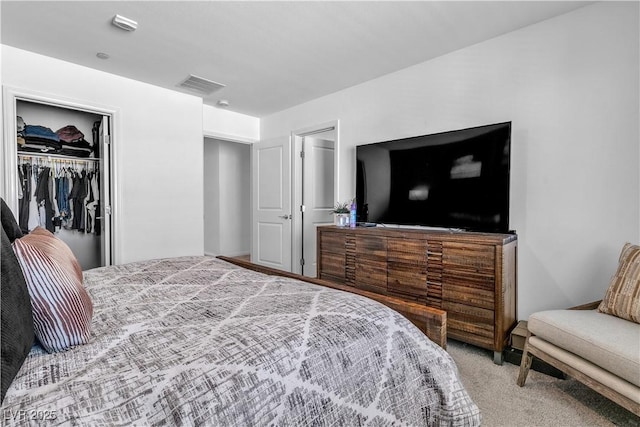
[260,2,640,319]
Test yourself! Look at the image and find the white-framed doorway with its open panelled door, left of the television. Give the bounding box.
[251,120,339,277]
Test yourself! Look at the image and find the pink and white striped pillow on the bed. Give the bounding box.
[13,239,93,352]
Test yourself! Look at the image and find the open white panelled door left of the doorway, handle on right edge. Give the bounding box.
[251,136,292,271]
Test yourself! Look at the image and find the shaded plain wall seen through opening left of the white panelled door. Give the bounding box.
[204,138,251,256]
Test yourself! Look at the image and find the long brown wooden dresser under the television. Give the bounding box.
[317,226,517,364]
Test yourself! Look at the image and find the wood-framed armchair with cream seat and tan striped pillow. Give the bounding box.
[517,243,640,416]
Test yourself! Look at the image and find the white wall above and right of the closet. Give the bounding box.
[2,45,203,263]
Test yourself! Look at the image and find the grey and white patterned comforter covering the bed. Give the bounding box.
[2,257,480,426]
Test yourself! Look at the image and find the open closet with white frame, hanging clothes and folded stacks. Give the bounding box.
[2,88,114,270]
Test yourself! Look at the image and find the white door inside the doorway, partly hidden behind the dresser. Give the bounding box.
[301,136,335,277]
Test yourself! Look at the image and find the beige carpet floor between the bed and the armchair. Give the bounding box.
[447,340,640,427]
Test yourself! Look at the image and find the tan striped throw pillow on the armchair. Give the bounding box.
[598,243,640,323]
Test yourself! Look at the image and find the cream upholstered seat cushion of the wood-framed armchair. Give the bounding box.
[527,310,640,387]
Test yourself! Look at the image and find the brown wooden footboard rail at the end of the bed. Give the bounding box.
[217,256,447,349]
